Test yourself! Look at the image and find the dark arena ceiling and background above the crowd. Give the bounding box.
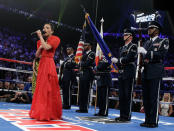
[0,0,174,50]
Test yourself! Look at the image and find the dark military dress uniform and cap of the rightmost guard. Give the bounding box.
[141,23,169,127]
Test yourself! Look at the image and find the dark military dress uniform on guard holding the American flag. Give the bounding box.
[76,50,95,113]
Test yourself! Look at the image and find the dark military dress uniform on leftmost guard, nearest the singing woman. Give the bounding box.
[61,54,76,109]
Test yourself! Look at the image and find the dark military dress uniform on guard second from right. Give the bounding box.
[116,42,137,121]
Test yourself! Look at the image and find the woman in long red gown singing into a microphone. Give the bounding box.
[29,23,62,121]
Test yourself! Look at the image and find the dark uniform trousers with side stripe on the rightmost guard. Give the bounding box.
[142,78,161,124]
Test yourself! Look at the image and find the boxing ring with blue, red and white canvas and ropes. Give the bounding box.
[0,58,174,131]
